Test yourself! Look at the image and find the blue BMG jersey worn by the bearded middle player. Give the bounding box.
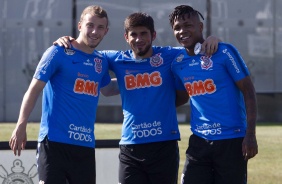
[103,47,183,144]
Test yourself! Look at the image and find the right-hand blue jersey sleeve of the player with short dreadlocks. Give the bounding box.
[222,44,250,81]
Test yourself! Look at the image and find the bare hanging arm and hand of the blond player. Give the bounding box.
[9,78,46,156]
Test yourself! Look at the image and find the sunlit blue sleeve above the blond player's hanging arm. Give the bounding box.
[33,46,62,82]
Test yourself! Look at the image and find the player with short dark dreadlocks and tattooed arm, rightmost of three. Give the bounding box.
[169,5,258,184]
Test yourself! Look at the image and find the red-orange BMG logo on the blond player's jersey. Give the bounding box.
[73,78,98,96]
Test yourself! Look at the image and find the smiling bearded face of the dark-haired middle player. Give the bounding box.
[124,26,156,58]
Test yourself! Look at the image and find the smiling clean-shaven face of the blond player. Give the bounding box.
[77,13,108,53]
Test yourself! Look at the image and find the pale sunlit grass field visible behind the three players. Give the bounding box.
[0,123,282,184]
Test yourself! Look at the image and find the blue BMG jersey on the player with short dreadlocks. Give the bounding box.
[172,43,249,140]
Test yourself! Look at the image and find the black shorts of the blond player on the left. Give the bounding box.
[37,138,96,184]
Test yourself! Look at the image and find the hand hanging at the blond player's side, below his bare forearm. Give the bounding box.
[9,125,27,156]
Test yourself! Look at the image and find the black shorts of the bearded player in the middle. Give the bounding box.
[119,140,179,184]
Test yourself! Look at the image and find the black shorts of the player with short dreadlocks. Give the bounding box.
[181,134,247,184]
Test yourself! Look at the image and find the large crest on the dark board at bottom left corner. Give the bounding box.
[0,159,37,184]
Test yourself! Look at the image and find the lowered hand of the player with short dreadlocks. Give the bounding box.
[242,134,258,160]
